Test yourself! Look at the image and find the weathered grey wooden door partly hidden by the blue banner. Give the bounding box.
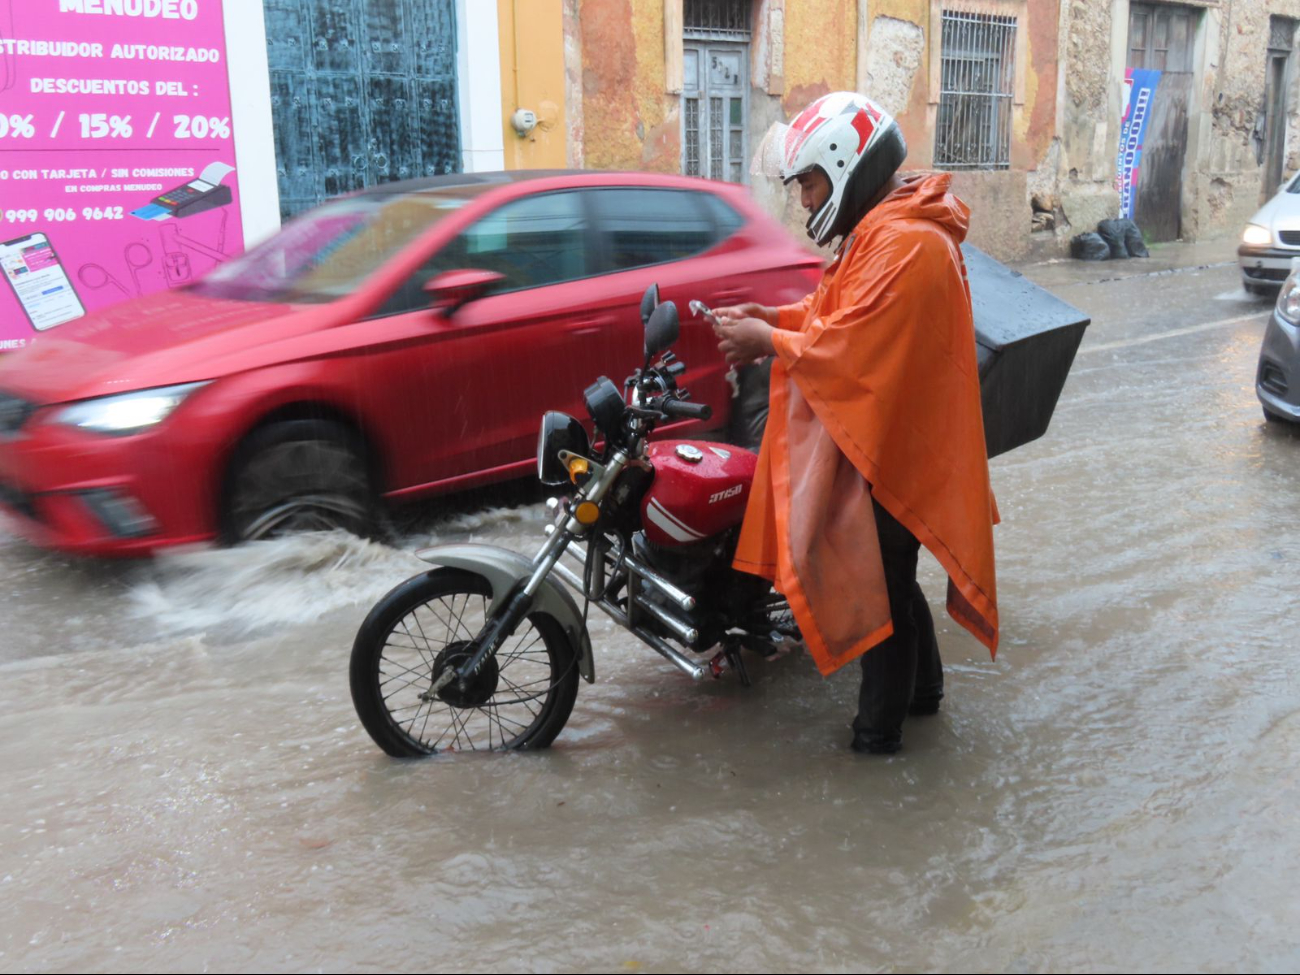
[1128,3,1199,241]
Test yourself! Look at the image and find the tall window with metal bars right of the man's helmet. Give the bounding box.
[935,10,1015,169]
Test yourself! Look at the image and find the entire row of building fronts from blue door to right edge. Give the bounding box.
[165,0,1300,260]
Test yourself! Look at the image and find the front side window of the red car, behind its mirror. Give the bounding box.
[374,192,588,317]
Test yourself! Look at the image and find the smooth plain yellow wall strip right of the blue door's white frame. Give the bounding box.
[499,0,568,169]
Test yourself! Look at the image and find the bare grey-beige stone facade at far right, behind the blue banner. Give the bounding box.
[1052,0,1300,252]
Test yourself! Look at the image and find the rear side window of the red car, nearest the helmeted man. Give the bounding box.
[590,189,725,270]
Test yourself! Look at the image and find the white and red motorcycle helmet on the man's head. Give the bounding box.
[781,91,907,244]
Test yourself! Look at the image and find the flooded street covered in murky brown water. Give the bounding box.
[0,253,1300,972]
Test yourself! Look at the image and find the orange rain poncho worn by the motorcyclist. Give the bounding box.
[735,174,997,673]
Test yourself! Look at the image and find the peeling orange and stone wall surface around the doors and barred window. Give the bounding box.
[564,0,1300,259]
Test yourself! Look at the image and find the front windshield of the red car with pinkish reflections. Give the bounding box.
[194,186,486,304]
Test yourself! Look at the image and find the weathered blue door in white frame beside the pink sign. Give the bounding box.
[263,0,460,218]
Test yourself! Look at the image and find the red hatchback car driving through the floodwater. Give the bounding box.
[0,173,820,555]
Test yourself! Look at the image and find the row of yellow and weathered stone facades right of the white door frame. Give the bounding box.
[497,0,1300,260]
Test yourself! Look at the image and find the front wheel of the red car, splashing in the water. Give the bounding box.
[221,420,376,545]
